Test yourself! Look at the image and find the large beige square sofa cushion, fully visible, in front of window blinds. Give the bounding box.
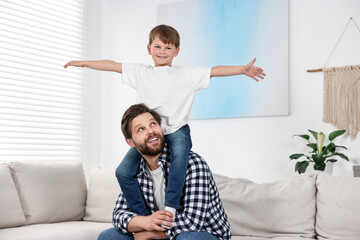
[9,162,87,224]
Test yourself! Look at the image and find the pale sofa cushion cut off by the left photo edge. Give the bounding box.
[0,163,25,228]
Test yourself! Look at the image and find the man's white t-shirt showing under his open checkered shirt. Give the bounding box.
[147,166,165,210]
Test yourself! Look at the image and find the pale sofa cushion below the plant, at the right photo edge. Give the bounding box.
[315,176,360,240]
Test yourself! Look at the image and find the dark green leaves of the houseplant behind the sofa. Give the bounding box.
[289,129,349,174]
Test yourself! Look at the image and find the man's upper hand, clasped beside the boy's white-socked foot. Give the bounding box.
[144,210,174,232]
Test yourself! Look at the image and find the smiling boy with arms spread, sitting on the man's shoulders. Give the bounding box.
[64,25,265,227]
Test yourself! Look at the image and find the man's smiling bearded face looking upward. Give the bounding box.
[126,113,165,156]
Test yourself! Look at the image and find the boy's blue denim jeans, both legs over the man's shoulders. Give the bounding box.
[116,125,192,215]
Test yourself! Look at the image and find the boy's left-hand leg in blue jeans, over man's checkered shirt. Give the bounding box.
[115,148,151,216]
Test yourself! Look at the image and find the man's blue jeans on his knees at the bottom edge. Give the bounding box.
[98,228,219,240]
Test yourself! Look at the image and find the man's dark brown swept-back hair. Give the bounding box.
[121,103,161,139]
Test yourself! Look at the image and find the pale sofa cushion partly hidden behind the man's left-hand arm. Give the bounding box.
[84,167,120,222]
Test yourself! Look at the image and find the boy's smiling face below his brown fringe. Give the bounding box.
[147,37,180,67]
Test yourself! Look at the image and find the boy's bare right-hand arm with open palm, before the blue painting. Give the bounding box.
[211,58,266,81]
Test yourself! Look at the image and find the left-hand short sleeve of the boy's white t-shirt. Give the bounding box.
[121,63,147,88]
